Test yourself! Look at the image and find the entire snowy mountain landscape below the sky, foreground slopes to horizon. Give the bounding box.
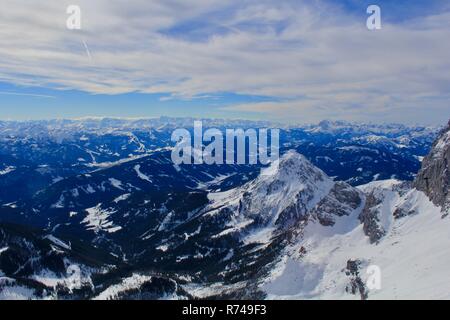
[0,118,450,299]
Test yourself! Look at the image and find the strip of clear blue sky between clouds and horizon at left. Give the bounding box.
[0,83,276,120]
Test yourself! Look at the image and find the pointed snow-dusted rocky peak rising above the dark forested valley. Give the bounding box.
[208,151,362,242]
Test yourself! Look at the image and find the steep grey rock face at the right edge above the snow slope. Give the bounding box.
[414,122,450,214]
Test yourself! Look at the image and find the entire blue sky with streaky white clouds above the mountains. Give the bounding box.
[0,0,450,125]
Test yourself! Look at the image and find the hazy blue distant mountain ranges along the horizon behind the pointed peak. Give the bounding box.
[0,118,439,204]
